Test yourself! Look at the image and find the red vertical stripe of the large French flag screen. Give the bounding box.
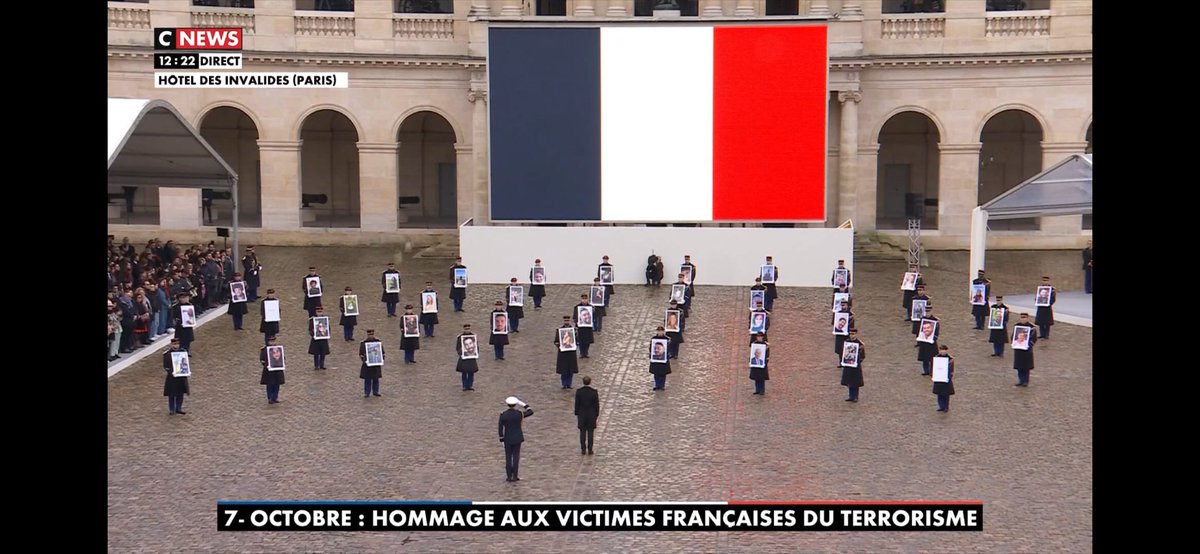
[713,25,828,221]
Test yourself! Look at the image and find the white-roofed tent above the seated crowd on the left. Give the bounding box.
[108,98,238,253]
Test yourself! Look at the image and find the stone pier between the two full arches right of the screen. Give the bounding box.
[937,143,982,238]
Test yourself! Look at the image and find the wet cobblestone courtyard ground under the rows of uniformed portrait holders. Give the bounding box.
[108,247,1092,553]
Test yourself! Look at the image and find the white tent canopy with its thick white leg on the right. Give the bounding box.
[967,153,1092,279]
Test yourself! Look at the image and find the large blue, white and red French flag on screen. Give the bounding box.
[488,22,828,222]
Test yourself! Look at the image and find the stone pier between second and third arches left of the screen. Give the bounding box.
[258,140,301,230]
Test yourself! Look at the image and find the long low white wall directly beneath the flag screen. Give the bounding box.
[458,227,854,287]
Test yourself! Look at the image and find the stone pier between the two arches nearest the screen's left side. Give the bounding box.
[358,141,400,231]
